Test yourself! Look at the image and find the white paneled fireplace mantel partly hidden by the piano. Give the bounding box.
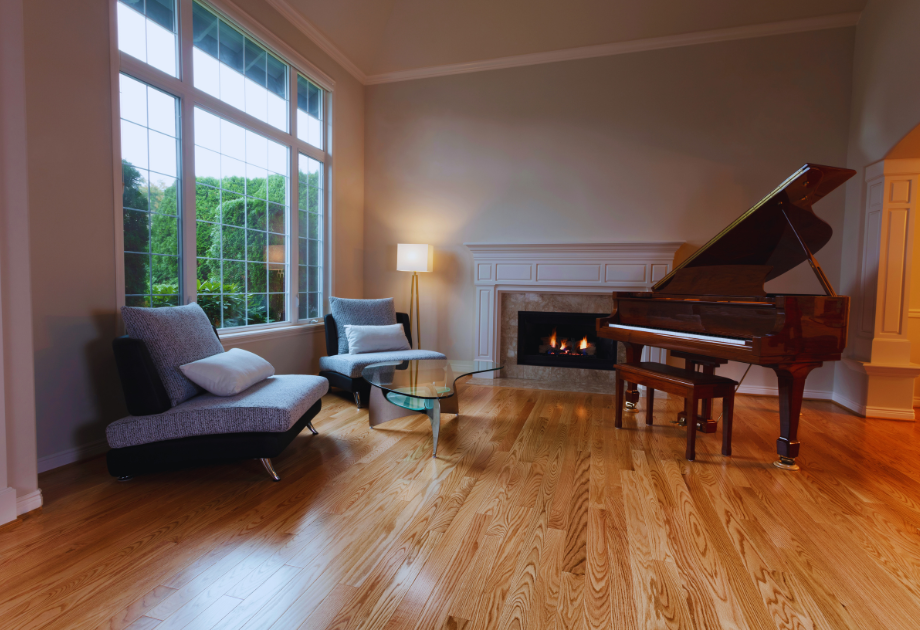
[464,242,683,361]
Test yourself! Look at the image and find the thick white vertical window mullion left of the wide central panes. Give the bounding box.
[179,0,198,304]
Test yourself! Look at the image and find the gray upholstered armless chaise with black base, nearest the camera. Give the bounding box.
[106,304,329,481]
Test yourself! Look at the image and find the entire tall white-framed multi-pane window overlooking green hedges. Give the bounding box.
[113,0,331,329]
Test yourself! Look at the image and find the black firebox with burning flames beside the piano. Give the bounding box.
[517,311,617,370]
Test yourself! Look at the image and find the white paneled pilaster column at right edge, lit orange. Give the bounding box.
[847,159,920,421]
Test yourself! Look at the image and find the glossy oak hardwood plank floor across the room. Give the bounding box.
[0,386,920,630]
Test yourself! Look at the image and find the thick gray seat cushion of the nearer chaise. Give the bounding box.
[105,376,329,448]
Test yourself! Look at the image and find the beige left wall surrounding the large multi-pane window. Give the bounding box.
[25,0,364,466]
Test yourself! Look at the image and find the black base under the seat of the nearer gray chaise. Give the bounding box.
[106,400,323,481]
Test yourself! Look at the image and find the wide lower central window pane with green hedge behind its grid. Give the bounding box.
[195,108,290,327]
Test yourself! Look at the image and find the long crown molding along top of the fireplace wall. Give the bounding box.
[366,11,860,85]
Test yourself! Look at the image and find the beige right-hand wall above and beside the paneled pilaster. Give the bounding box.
[836,0,920,399]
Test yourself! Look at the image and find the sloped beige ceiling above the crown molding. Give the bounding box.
[273,0,866,76]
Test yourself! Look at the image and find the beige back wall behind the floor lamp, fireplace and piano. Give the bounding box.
[364,29,854,398]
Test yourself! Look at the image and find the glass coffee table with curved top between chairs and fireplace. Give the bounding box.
[361,359,502,457]
